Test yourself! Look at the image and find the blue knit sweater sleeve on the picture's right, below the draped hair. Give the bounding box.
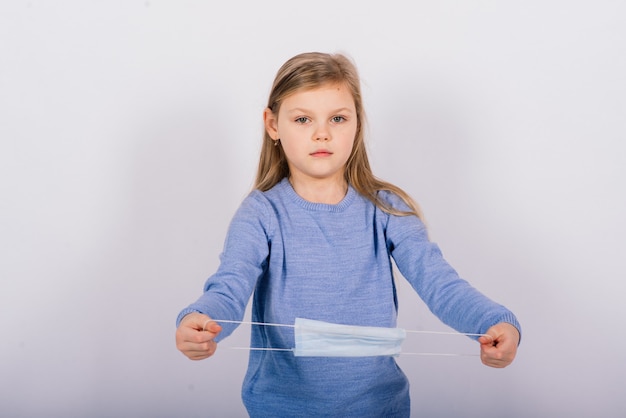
[386,193,521,335]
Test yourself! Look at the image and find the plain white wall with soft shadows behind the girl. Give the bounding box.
[0,0,626,418]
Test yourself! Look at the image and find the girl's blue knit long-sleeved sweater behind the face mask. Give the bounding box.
[177,179,519,417]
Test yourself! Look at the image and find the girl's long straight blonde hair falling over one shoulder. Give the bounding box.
[254,52,422,218]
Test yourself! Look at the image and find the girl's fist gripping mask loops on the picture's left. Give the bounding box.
[176,313,222,360]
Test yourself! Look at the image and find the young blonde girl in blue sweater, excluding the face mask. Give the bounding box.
[176,53,520,417]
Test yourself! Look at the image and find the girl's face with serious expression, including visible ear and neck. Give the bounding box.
[264,84,357,189]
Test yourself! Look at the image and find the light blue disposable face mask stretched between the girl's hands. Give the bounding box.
[294,318,406,357]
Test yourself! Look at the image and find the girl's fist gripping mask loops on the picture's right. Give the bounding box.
[478,322,520,368]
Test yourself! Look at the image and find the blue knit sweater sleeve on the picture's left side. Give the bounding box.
[176,192,271,342]
